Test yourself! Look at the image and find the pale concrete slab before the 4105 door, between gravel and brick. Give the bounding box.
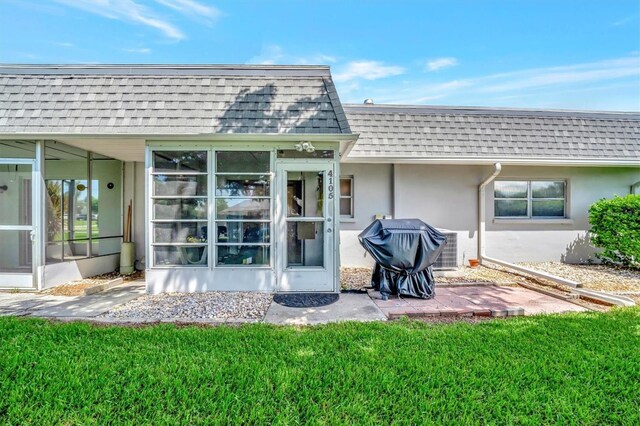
[264,293,387,325]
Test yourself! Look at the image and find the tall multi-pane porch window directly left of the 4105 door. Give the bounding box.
[214,151,271,266]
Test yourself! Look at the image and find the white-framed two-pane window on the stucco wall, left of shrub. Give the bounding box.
[494,180,567,219]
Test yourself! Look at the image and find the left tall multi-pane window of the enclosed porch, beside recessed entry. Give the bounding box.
[151,151,209,267]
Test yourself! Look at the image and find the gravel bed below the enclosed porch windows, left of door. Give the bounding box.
[101,291,273,320]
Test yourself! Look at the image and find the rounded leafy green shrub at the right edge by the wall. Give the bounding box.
[589,195,640,268]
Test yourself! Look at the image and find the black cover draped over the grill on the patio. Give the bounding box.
[358,219,447,299]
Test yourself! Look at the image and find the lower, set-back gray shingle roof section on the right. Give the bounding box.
[344,105,640,164]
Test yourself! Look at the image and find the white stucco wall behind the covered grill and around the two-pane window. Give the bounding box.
[340,164,640,266]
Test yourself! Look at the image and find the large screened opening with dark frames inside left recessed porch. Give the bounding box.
[44,141,122,264]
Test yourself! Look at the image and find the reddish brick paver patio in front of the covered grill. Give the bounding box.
[369,285,586,319]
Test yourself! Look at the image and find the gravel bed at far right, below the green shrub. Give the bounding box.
[520,262,640,295]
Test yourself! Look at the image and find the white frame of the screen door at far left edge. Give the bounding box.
[0,158,41,289]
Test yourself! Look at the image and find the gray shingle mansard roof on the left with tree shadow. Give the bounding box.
[0,65,350,135]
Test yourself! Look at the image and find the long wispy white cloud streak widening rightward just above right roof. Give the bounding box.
[350,55,640,110]
